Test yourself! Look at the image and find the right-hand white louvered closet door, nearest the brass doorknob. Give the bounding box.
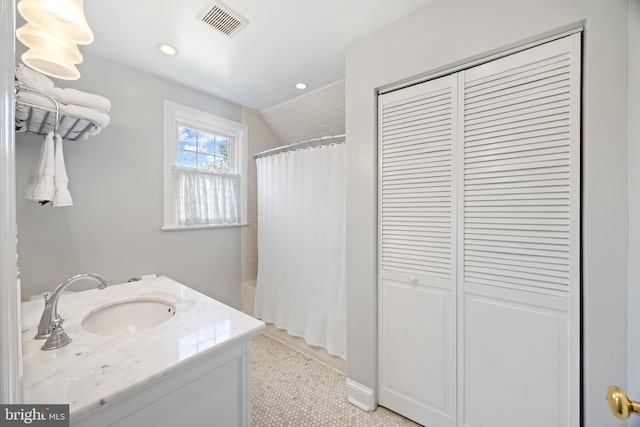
[458,34,580,427]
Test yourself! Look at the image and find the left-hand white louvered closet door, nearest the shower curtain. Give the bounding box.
[379,76,457,427]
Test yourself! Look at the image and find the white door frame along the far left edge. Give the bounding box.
[0,0,22,403]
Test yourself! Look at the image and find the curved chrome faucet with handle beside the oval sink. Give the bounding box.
[35,273,107,350]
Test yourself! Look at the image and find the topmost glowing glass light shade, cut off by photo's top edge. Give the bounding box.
[18,0,93,44]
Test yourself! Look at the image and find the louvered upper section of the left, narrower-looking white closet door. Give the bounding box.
[380,80,456,279]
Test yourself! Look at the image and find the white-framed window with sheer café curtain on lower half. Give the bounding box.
[162,100,247,230]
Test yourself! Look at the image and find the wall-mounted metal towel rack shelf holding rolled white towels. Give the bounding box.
[15,83,95,141]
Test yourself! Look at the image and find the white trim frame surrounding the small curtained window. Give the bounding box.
[160,99,248,231]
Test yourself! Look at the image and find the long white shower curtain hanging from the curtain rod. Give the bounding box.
[254,144,346,358]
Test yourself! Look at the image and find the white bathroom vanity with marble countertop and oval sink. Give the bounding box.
[22,277,264,427]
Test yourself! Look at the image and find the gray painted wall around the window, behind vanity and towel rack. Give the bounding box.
[16,56,241,308]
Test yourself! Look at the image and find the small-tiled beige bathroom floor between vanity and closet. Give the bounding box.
[252,334,418,427]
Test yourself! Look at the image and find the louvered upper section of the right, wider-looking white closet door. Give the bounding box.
[463,54,572,295]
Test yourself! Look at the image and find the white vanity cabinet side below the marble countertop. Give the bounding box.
[71,342,251,427]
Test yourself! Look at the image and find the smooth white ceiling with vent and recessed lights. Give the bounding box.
[79,0,430,110]
